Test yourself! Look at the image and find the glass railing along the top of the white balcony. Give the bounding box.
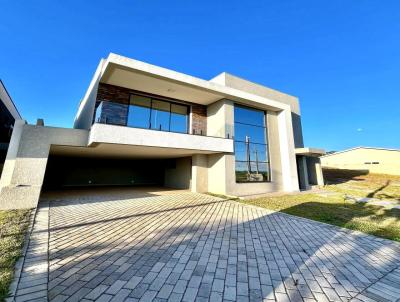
[93,101,233,139]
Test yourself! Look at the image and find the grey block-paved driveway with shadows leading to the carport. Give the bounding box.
[12,190,400,301]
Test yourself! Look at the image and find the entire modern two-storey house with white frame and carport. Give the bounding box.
[0,54,323,207]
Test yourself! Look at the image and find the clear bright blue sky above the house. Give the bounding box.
[0,0,400,150]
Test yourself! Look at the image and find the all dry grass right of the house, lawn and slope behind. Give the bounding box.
[241,170,400,241]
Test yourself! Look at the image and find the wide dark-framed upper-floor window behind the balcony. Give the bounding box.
[127,95,188,133]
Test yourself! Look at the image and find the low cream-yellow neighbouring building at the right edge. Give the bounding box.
[321,147,400,175]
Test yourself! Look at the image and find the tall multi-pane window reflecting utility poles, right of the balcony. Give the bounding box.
[234,105,271,182]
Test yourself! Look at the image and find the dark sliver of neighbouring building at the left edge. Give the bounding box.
[0,80,21,173]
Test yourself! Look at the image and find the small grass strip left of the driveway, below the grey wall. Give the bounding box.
[0,210,30,301]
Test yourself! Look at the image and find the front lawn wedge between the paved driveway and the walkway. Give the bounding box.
[240,194,400,242]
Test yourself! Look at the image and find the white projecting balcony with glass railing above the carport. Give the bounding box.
[89,102,233,154]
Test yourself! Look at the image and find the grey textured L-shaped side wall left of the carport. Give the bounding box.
[0,121,88,209]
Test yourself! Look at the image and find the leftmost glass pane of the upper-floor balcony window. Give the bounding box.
[128,95,151,128]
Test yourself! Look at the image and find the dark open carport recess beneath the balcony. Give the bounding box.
[43,144,192,190]
